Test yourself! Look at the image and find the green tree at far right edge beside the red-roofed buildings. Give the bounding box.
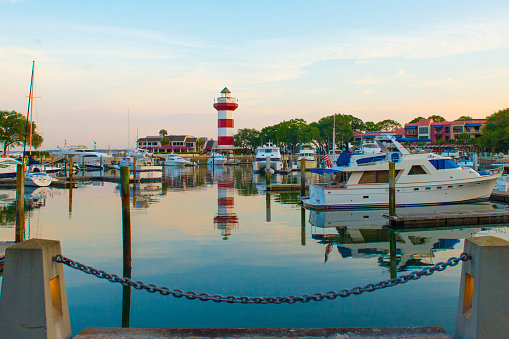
[479,108,509,152]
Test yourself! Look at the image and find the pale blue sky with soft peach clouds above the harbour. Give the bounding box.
[0,0,509,149]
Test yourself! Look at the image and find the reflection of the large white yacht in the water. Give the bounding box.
[309,202,506,273]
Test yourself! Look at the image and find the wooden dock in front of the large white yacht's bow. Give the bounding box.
[383,208,509,229]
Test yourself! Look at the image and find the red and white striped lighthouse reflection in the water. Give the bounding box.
[212,166,239,240]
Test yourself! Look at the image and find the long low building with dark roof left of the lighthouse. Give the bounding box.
[137,135,207,153]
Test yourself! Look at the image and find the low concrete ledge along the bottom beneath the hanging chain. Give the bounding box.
[74,327,450,339]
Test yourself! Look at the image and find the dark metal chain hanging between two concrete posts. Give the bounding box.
[53,253,470,304]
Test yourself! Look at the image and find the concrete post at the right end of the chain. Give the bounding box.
[454,236,509,339]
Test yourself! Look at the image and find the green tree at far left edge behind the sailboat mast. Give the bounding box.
[0,111,44,155]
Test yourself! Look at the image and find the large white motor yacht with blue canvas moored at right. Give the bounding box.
[302,136,502,209]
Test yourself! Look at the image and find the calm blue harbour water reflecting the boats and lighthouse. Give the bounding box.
[0,167,509,335]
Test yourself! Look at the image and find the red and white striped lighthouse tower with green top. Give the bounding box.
[214,87,239,148]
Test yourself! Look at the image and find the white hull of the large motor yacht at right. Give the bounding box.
[302,173,501,209]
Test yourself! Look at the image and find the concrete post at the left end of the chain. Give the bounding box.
[0,239,72,339]
